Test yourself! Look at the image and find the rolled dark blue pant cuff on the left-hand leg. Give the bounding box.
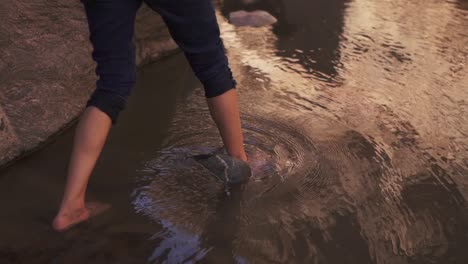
[86,90,126,124]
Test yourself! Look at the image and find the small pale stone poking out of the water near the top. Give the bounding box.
[229,10,278,27]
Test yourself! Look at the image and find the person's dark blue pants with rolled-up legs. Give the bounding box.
[82,0,236,123]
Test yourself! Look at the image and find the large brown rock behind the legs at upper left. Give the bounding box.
[0,0,176,166]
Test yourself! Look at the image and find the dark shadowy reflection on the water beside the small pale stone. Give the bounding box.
[221,0,349,84]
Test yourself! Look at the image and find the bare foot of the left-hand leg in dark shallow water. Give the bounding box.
[52,202,110,231]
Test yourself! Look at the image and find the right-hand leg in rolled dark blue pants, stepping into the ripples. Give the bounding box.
[145,0,247,160]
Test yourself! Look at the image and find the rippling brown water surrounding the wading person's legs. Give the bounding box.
[0,0,468,263]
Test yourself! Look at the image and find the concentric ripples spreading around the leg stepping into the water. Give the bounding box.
[130,111,350,260]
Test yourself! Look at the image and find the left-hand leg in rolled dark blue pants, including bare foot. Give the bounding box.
[53,0,141,230]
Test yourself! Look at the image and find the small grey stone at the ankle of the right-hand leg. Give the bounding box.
[193,154,252,183]
